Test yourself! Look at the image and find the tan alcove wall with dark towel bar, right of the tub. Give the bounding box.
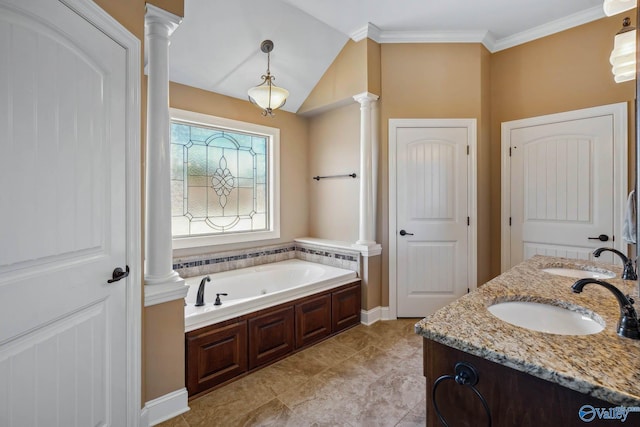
[305,101,360,242]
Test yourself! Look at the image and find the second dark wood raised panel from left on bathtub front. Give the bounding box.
[249,306,294,369]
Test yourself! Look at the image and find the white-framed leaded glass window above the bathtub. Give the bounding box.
[171,109,280,248]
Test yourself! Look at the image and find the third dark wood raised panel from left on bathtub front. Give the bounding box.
[296,294,331,348]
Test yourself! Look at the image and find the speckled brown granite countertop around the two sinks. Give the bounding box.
[415,256,640,406]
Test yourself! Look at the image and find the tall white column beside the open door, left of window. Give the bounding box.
[144,4,184,298]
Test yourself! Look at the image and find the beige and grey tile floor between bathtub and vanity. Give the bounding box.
[159,319,426,427]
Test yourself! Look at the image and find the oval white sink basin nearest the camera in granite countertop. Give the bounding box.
[488,301,604,335]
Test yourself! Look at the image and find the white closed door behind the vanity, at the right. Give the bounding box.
[507,104,626,267]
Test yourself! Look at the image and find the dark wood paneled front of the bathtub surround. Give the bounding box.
[185,280,361,397]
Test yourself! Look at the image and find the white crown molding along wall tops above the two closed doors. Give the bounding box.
[349,6,605,53]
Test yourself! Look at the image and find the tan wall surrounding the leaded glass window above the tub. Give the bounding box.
[169,83,311,256]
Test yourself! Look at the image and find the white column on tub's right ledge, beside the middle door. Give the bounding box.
[353,92,379,246]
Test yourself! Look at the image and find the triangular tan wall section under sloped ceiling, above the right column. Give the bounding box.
[298,39,369,114]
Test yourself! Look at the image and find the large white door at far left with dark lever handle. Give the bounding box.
[0,0,135,427]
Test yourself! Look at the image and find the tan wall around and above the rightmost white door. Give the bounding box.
[490,15,635,275]
